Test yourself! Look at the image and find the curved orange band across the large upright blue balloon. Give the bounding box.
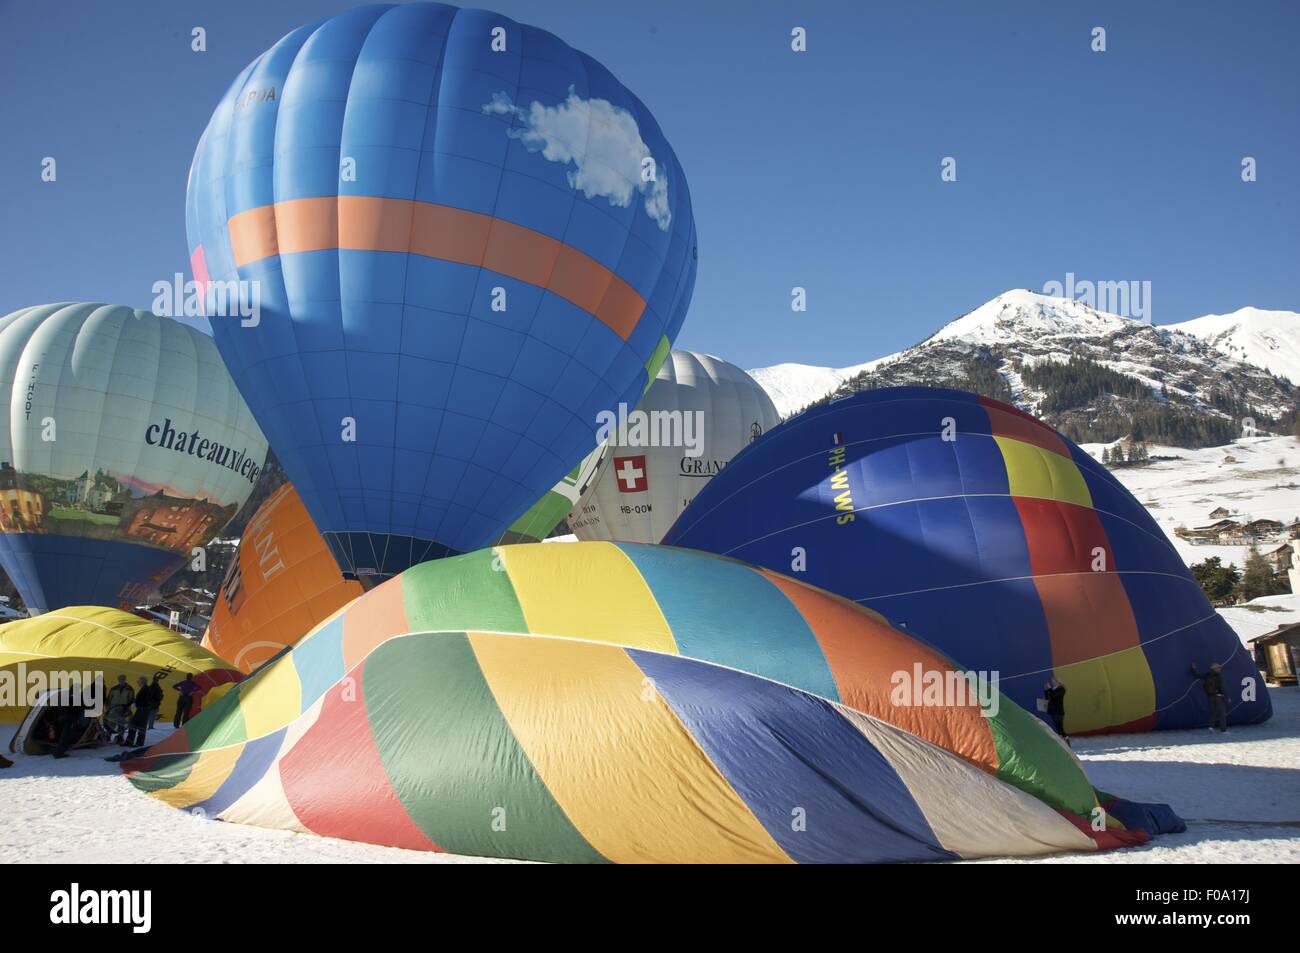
[229,195,646,341]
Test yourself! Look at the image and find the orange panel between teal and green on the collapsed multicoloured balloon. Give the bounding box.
[759,569,998,774]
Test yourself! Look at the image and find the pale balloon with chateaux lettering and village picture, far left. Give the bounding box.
[0,304,267,612]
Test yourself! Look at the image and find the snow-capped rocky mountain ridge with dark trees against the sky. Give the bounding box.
[749,290,1300,446]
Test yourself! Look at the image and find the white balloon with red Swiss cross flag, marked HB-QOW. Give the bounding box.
[568,350,781,542]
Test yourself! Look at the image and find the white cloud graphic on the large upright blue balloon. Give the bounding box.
[482,86,672,231]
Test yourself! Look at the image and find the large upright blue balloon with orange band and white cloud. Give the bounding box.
[186,3,696,579]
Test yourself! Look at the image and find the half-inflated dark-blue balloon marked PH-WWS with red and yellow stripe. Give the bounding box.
[664,387,1271,733]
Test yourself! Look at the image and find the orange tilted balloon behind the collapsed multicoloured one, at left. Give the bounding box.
[203,484,361,672]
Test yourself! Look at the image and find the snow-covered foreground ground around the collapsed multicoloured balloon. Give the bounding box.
[0,688,1300,863]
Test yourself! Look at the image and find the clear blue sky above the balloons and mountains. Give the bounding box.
[0,0,1300,367]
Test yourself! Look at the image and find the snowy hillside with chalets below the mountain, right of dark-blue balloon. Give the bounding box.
[1083,437,1300,567]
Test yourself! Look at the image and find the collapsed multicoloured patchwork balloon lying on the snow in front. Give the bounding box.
[126,542,1180,862]
